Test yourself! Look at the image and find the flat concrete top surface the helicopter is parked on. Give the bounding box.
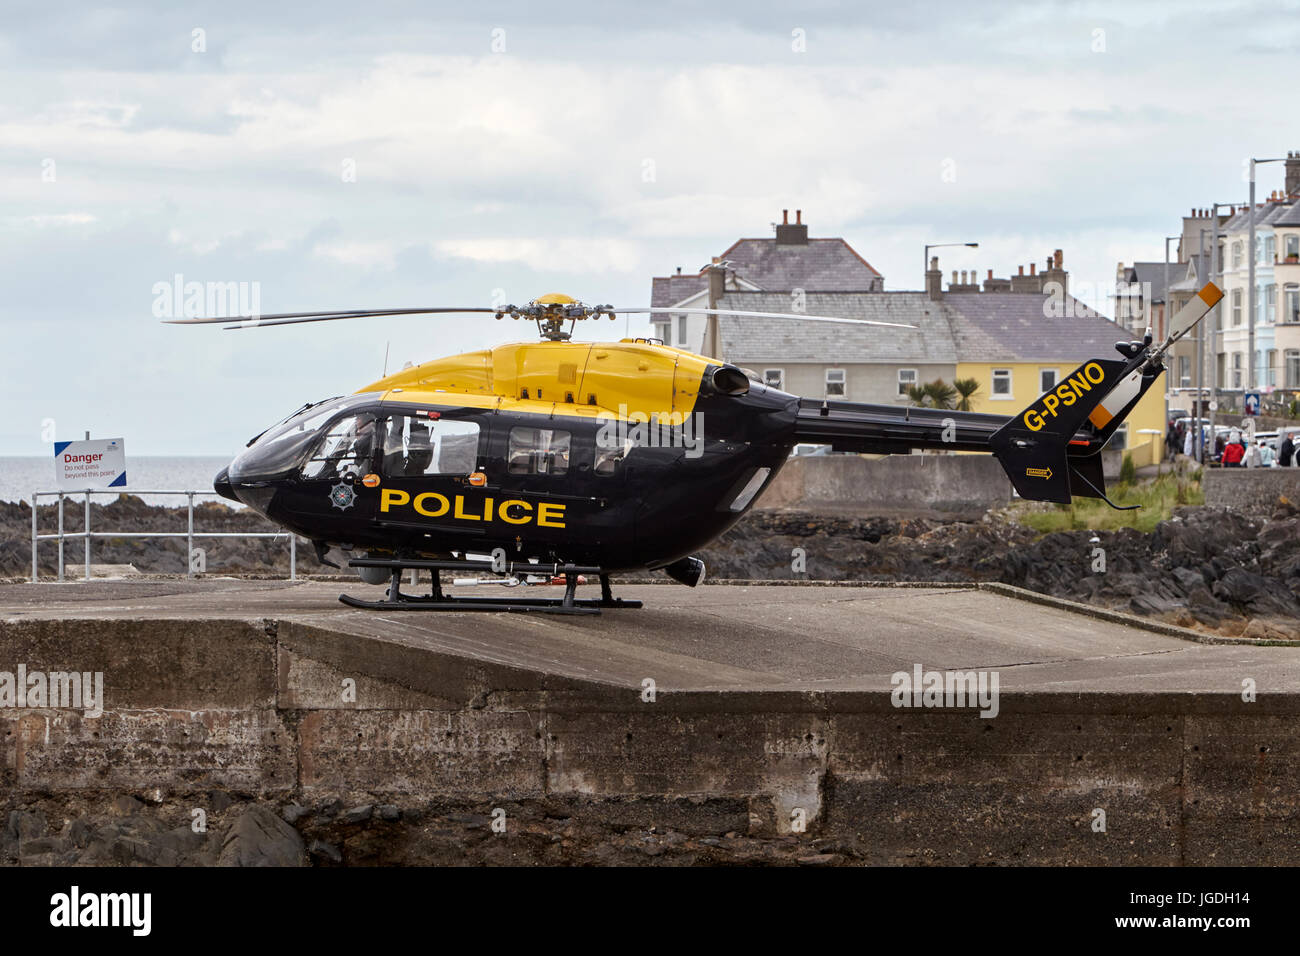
[0,579,1300,693]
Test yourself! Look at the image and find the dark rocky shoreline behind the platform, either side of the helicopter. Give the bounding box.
[0,496,1300,640]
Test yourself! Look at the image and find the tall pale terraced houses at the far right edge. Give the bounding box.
[1115,152,1300,408]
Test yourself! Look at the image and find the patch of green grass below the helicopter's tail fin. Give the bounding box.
[1010,471,1205,535]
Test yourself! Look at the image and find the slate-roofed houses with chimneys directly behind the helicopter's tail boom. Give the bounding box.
[651,217,1165,466]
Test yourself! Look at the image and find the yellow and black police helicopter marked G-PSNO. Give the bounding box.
[172,285,1222,614]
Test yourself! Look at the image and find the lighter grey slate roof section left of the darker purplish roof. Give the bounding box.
[718,293,957,365]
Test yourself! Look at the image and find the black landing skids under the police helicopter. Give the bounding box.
[338,558,641,614]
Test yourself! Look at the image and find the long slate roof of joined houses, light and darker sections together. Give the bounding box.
[719,287,1128,365]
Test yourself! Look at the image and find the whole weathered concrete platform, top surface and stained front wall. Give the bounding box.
[0,580,1300,864]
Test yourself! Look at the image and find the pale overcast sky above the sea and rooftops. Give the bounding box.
[0,0,1300,455]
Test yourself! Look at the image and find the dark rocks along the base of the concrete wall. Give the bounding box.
[0,791,852,866]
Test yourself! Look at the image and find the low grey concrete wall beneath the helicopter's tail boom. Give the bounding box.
[754,455,1011,519]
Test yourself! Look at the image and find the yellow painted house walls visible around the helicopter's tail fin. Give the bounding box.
[956,352,1167,468]
